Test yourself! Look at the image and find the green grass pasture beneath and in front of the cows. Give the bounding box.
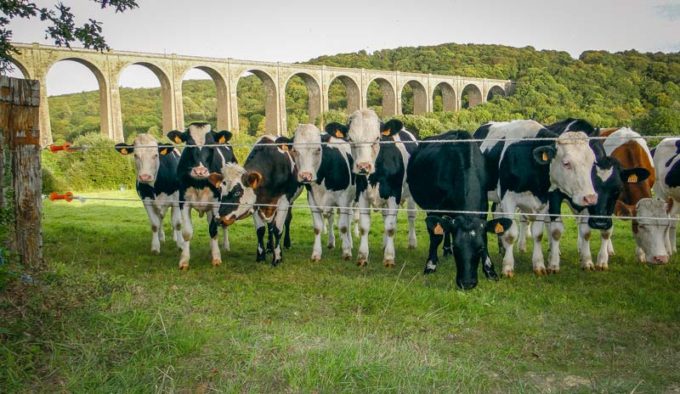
[0,192,680,392]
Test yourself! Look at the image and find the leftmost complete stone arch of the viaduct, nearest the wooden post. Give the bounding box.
[40,56,109,144]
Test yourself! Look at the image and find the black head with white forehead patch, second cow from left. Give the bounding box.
[168,123,232,180]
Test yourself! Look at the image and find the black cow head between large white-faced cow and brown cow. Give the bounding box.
[588,156,649,230]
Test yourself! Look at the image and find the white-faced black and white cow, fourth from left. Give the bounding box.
[291,124,356,261]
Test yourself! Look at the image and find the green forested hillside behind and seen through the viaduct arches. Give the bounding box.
[50,44,680,140]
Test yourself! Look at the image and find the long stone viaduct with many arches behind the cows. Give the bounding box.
[13,44,513,145]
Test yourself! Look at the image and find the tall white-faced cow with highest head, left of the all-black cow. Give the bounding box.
[348,109,417,267]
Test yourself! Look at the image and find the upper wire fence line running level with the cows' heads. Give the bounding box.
[45,135,680,152]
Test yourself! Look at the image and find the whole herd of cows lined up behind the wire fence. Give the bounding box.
[116,110,680,289]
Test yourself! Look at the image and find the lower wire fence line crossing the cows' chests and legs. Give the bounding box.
[43,195,680,222]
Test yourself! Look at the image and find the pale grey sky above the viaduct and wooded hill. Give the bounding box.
[5,0,680,95]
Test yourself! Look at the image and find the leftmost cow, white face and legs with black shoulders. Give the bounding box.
[116,134,184,253]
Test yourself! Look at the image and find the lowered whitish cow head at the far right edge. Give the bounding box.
[633,198,672,264]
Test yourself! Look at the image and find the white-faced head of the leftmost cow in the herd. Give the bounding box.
[116,134,175,185]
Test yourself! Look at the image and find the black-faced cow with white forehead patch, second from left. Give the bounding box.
[168,122,236,270]
